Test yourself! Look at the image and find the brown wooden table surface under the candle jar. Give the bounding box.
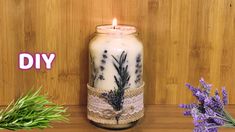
[2,105,235,132]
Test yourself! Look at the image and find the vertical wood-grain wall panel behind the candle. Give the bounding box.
[0,0,235,105]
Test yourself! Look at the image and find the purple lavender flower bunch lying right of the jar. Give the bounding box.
[180,78,235,132]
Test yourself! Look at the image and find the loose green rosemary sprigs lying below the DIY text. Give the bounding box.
[0,88,68,130]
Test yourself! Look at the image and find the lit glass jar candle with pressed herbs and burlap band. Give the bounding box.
[87,20,144,129]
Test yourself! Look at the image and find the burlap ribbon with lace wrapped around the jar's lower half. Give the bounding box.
[87,83,144,124]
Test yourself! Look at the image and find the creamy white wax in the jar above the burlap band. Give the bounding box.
[89,26,143,90]
